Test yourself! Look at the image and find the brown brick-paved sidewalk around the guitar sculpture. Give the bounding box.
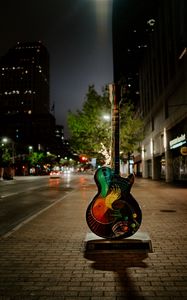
[0,176,187,300]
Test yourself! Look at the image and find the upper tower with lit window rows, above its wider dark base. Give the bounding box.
[0,42,49,114]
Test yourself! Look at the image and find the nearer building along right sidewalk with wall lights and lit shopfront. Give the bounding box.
[138,0,187,182]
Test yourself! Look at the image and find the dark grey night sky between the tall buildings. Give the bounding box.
[0,0,113,134]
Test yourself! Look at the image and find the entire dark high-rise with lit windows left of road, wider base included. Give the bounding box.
[0,41,55,153]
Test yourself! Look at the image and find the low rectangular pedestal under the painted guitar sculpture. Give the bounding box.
[84,231,153,253]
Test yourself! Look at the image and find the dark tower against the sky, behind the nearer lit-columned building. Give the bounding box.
[112,0,156,106]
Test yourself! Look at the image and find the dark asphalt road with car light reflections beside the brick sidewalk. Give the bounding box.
[0,174,80,236]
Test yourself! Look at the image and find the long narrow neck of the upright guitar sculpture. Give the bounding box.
[111,84,120,175]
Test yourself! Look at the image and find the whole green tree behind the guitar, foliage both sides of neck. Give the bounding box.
[68,85,143,164]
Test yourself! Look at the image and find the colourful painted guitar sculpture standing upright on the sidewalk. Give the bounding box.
[86,84,142,239]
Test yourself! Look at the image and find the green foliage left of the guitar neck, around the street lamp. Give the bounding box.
[68,85,110,156]
